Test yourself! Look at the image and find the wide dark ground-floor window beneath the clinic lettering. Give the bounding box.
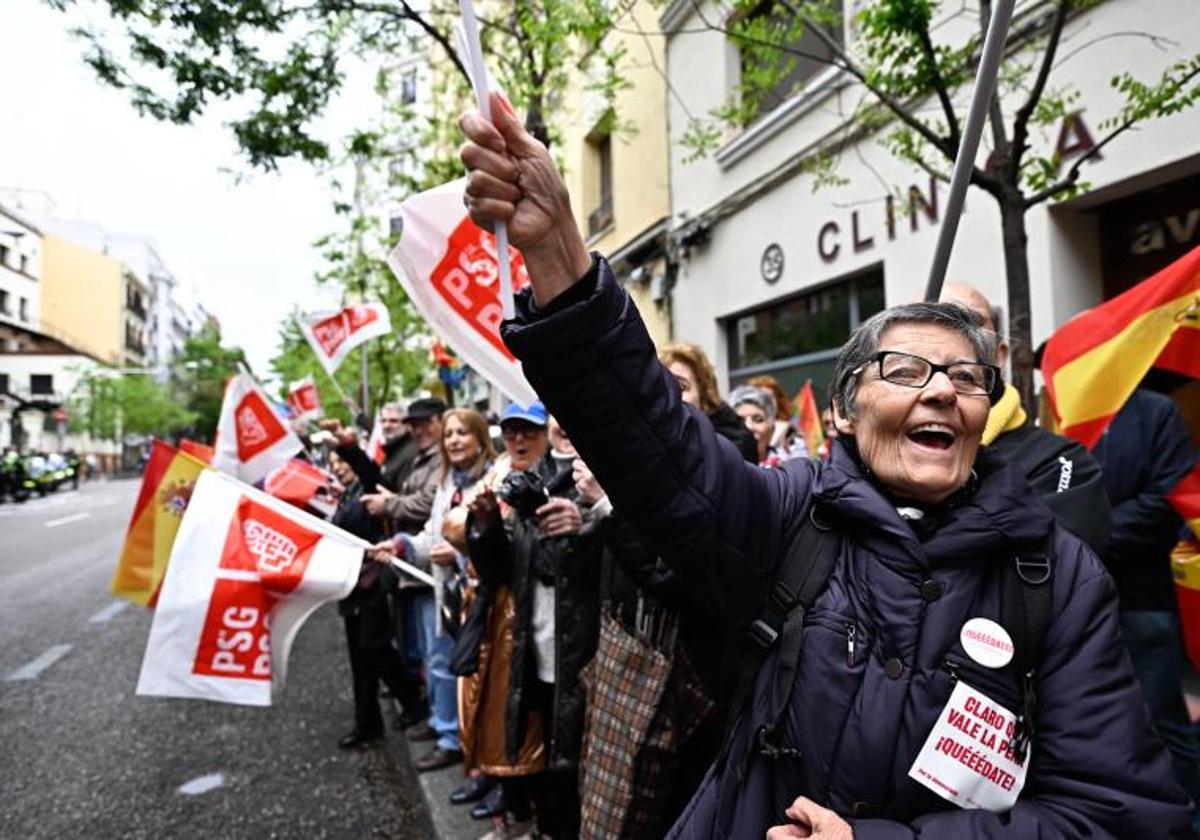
[725,266,884,401]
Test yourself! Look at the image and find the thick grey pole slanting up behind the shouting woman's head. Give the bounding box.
[921,0,1015,302]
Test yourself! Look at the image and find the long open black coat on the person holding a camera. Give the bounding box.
[467,455,600,770]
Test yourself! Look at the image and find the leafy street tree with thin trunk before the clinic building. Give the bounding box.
[684,0,1200,410]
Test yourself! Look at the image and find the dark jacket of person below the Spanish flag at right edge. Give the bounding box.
[1092,390,1195,611]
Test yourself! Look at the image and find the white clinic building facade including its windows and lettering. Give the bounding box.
[660,0,1200,392]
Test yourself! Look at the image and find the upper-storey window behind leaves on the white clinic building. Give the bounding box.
[732,0,845,126]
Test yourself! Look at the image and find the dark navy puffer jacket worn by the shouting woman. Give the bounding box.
[504,260,1188,840]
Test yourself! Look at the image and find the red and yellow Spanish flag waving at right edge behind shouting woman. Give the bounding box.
[1042,247,1200,449]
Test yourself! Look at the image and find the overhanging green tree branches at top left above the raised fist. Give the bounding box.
[46,0,630,169]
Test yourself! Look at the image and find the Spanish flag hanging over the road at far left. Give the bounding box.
[113,440,206,607]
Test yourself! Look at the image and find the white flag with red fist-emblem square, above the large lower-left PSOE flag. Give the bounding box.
[211,373,304,484]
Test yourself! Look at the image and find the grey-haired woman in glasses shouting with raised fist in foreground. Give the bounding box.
[462,97,1188,838]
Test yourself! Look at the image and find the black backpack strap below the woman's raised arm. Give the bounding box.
[727,504,839,778]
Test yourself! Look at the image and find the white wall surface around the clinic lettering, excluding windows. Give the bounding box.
[665,0,1200,376]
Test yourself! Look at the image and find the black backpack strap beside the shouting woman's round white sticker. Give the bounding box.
[1002,534,1054,762]
